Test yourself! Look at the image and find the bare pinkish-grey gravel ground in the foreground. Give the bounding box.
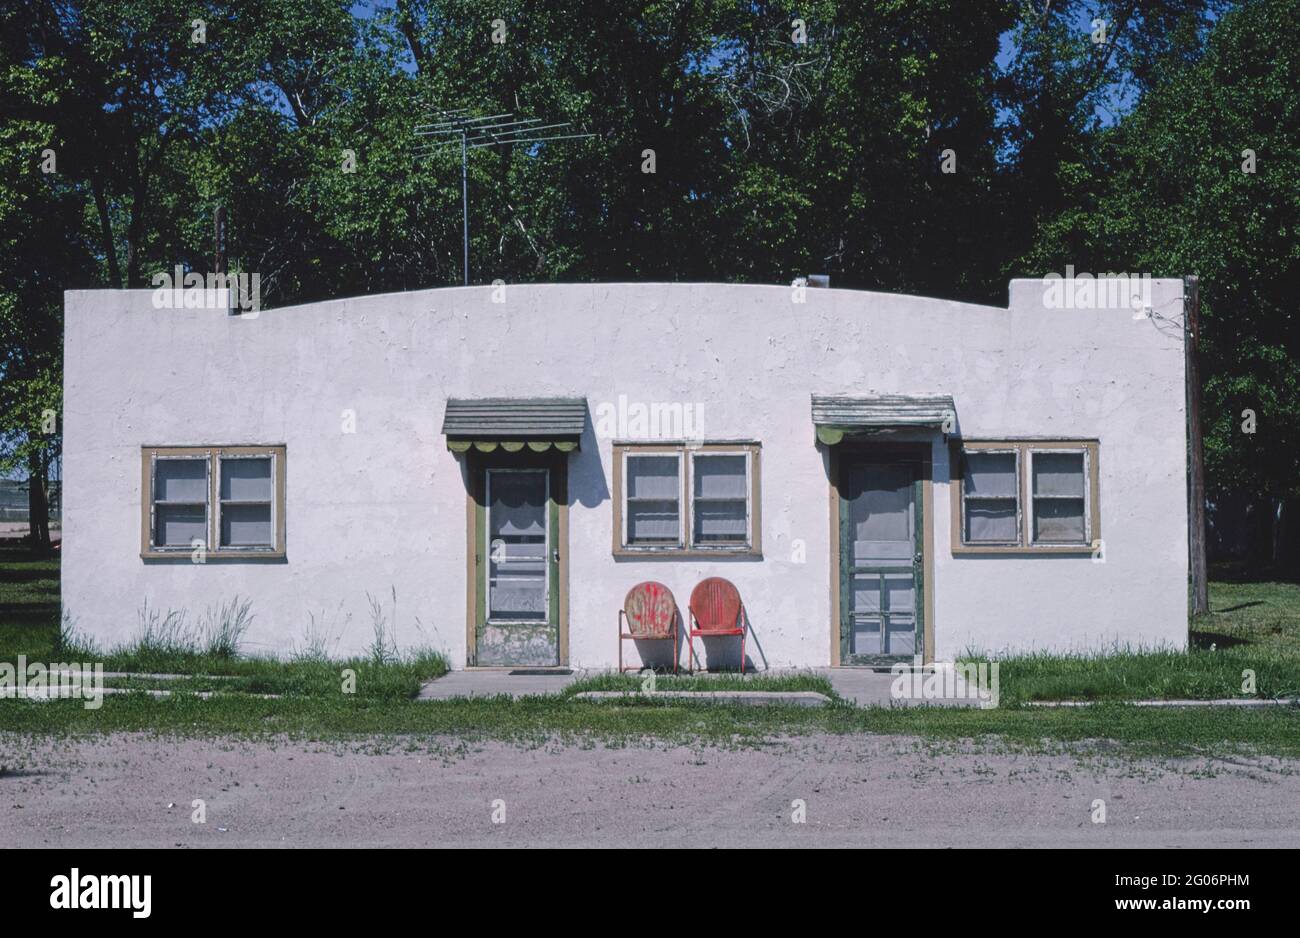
[0,734,1300,847]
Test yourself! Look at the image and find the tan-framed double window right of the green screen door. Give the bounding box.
[952,439,1101,553]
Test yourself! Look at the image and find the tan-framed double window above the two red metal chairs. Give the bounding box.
[614,443,762,556]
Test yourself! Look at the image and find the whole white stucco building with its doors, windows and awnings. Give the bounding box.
[62,279,1188,669]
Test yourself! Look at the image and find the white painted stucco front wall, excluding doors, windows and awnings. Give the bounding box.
[62,281,1187,666]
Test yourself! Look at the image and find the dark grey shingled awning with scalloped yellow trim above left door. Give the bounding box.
[442,398,586,452]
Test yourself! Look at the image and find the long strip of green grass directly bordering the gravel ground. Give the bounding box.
[0,695,1300,757]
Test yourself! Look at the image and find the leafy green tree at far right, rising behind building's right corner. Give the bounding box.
[1026,0,1300,556]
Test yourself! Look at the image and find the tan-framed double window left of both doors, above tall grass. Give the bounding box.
[140,446,285,560]
